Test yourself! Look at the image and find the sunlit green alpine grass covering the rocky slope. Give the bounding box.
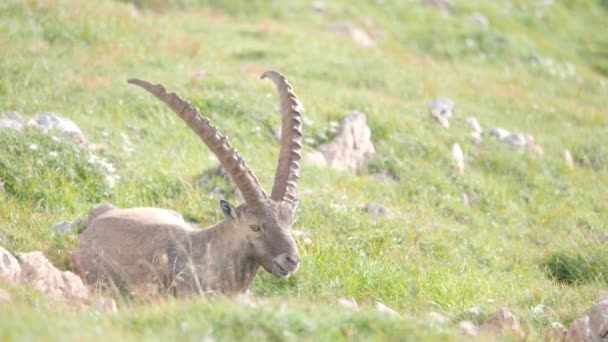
[0,0,608,340]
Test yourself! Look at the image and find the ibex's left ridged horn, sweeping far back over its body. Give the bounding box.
[128,78,266,208]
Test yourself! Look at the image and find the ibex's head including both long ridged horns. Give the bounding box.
[129,71,302,277]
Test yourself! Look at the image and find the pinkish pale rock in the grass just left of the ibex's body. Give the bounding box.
[19,252,89,301]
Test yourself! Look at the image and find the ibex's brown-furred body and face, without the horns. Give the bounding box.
[76,202,299,295]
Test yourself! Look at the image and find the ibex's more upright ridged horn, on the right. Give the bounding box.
[261,71,302,205]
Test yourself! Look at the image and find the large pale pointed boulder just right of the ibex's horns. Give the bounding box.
[318,112,376,171]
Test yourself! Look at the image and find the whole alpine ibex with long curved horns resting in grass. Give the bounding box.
[75,71,302,294]
